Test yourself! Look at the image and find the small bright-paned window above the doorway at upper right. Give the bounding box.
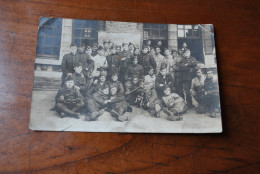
[178,25,201,38]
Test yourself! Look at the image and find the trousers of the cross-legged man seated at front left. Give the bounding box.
[56,101,85,115]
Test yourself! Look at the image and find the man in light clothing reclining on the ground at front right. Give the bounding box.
[156,85,187,121]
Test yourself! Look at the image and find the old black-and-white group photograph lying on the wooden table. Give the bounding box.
[30,17,222,133]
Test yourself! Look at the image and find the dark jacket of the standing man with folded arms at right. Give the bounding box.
[180,56,197,80]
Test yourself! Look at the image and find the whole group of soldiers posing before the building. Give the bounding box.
[54,40,219,121]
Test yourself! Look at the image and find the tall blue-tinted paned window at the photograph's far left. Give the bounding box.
[36,17,62,59]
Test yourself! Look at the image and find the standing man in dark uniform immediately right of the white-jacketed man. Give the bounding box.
[107,46,121,79]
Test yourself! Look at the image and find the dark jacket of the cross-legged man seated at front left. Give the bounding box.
[55,86,83,104]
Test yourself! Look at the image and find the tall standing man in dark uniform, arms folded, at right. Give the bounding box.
[180,50,197,107]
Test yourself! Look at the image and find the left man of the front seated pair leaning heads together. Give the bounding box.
[85,84,110,121]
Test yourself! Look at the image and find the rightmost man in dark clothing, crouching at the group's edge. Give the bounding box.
[202,71,219,118]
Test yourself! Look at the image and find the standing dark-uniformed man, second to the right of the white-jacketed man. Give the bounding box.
[119,43,133,83]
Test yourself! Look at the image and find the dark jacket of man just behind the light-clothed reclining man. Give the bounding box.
[155,74,176,98]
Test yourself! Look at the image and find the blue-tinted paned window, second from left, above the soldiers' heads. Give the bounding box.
[72,20,98,45]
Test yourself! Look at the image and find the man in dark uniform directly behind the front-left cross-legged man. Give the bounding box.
[72,62,87,95]
